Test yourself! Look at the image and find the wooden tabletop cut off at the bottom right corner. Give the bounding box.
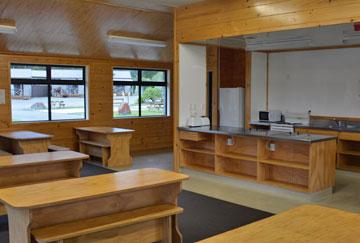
[200,205,360,243]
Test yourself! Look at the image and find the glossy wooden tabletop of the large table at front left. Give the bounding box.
[0,168,188,208]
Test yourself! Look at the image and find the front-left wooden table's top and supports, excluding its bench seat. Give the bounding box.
[0,168,188,243]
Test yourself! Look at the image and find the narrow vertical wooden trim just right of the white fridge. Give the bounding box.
[245,51,252,129]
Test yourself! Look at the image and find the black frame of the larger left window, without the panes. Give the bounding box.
[10,63,87,123]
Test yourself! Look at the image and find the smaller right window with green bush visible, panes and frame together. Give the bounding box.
[113,68,168,118]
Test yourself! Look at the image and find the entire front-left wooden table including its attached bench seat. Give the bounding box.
[0,169,189,243]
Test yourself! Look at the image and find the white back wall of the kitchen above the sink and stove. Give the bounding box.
[252,48,360,117]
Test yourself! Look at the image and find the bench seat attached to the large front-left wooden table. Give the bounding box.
[31,204,183,243]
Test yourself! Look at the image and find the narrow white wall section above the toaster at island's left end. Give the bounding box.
[179,44,206,126]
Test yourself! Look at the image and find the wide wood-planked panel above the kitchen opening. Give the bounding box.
[175,0,360,42]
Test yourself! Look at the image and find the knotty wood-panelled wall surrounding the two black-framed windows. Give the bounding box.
[0,55,173,152]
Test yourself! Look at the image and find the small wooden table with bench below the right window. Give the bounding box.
[75,127,134,167]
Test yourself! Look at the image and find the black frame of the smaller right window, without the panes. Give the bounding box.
[113,67,169,119]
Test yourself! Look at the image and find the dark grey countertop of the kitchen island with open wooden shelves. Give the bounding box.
[178,126,337,143]
